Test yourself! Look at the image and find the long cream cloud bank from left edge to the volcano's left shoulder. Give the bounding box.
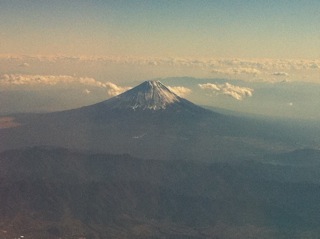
[0,74,130,96]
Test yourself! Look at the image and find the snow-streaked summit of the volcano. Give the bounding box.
[107,81,181,110]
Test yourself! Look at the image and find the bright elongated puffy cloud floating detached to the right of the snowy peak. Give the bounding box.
[199,83,254,100]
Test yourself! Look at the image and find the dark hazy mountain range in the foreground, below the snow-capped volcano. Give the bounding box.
[0,147,320,239]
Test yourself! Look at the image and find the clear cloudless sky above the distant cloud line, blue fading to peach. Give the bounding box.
[0,0,320,59]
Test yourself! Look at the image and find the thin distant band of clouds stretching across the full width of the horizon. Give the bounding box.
[0,55,320,71]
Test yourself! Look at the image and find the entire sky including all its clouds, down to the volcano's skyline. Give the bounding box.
[0,0,320,120]
